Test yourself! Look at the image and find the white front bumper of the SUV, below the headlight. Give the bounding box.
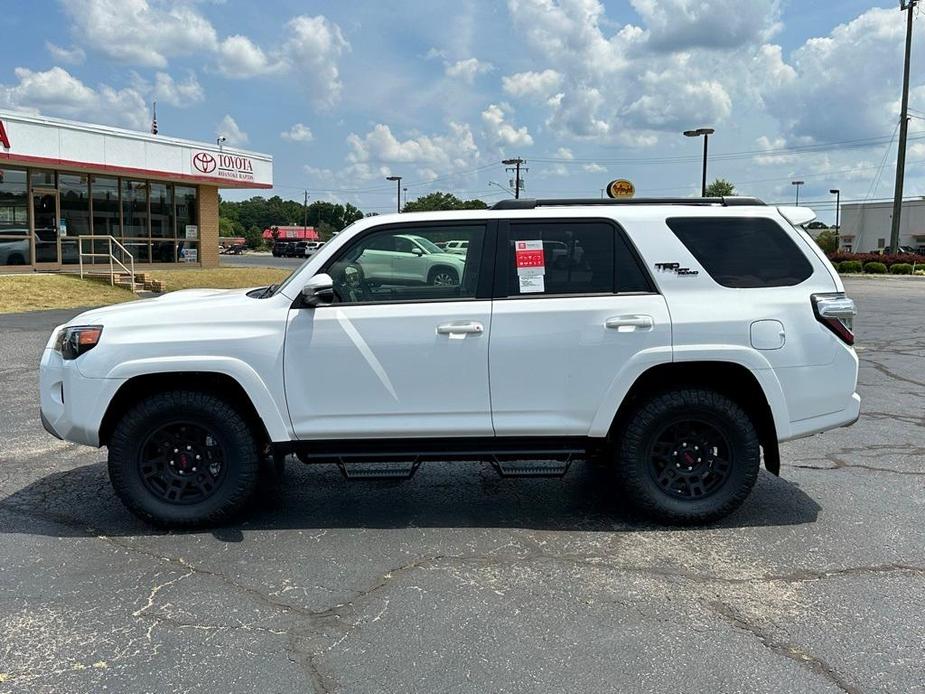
[39,348,124,447]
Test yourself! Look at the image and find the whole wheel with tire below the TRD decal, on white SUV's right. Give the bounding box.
[616,389,761,524]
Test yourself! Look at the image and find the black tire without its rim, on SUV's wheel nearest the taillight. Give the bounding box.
[615,388,761,525]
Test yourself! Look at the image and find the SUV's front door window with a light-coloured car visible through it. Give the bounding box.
[326,224,485,303]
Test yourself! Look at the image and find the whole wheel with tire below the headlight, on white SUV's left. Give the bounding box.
[109,391,260,527]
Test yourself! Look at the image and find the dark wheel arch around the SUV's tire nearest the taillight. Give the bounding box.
[610,361,780,475]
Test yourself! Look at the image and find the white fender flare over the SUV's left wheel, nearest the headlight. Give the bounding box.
[106,356,294,443]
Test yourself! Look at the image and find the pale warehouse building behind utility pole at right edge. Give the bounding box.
[839,198,925,253]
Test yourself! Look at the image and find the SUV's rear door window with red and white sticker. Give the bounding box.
[504,219,650,296]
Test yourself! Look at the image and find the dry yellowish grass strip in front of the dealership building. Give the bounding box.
[0,268,289,313]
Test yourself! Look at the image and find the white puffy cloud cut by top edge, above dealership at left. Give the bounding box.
[62,0,217,68]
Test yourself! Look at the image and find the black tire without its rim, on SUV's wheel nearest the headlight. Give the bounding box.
[109,390,260,528]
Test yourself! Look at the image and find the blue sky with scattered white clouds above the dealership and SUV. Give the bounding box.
[0,0,925,221]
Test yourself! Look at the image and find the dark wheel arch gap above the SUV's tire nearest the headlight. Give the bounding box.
[99,371,275,445]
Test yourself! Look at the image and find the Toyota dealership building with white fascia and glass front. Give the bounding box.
[0,111,273,272]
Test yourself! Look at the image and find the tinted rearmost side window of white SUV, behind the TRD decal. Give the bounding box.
[666,217,813,289]
